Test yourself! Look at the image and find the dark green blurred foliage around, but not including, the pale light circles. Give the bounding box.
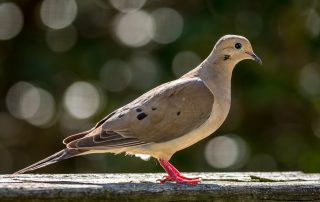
[0,0,320,173]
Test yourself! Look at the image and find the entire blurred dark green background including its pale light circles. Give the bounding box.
[0,0,320,173]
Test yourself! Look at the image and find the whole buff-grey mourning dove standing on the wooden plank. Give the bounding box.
[14,35,262,184]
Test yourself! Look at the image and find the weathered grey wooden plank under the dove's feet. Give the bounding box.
[0,172,320,202]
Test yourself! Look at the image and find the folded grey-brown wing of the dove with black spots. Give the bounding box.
[67,77,214,149]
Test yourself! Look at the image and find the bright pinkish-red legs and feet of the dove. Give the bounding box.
[158,159,200,184]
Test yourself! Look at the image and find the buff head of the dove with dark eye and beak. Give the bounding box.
[214,35,262,64]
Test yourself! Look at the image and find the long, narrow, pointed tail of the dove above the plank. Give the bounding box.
[14,148,85,174]
